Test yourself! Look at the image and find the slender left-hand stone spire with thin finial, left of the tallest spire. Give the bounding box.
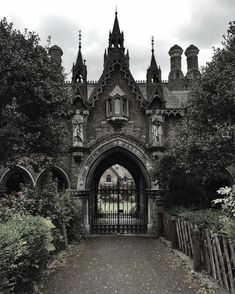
[72,31,87,83]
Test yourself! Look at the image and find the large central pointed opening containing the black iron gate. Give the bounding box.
[86,147,149,234]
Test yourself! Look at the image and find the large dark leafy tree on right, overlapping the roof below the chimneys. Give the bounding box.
[156,22,235,202]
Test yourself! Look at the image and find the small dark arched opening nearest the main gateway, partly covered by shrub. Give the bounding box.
[36,166,70,191]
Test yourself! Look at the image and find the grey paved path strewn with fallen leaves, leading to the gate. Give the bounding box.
[43,236,221,294]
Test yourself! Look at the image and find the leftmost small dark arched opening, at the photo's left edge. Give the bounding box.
[1,166,34,194]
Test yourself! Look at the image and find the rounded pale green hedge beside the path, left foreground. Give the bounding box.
[0,215,54,294]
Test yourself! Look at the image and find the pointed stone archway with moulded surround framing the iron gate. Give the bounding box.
[78,139,152,233]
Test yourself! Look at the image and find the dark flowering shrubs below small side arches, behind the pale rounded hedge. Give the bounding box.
[0,174,83,251]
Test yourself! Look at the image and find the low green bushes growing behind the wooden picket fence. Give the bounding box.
[169,207,222,233]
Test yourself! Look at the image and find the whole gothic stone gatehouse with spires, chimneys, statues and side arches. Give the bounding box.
[0,12,200,233]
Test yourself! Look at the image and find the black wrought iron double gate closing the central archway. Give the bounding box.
[90,185,147,234]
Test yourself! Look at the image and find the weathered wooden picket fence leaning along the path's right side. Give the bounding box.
[161,212,235,294]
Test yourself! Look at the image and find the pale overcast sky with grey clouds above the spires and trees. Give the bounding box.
[0,0,235,80]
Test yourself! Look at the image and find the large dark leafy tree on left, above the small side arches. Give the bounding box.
[0,19,68,164]
